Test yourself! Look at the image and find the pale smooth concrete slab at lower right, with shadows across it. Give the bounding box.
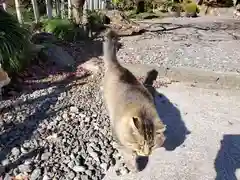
[104,84,240,180]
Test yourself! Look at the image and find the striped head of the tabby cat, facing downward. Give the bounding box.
[125,109,166,156]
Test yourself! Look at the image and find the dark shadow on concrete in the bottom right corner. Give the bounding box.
[215,134,240,180]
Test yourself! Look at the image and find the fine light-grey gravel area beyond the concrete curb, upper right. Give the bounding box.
[118,18,240,73]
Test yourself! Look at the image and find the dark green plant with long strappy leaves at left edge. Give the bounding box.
[0,9,30,73]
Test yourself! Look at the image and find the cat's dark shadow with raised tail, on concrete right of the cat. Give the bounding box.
[144,70,190,151]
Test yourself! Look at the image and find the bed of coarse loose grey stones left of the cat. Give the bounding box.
[0,71,131,180]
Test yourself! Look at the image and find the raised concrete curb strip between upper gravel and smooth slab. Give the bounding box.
[122,63,240,89]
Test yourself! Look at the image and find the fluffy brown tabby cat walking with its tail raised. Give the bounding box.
[103,30,166,170]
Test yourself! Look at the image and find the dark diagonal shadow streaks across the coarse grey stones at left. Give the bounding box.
[0,73,85,174]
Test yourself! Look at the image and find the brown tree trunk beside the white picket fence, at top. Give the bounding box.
[72,0,85,25]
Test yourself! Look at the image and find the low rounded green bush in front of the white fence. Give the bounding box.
[43,18,74,40]
